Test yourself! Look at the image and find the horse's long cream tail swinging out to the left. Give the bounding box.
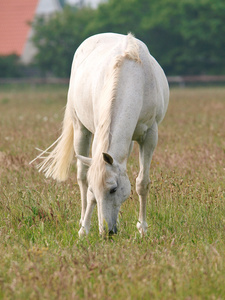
[30,106,74,181]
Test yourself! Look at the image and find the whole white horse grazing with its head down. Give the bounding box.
[31,33,169,236]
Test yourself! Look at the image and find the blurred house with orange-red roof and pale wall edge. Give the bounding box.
[0,0,62,64]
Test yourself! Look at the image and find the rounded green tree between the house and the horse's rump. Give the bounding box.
[33,7,94,77]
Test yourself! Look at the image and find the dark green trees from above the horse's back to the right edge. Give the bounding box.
[89,0,225,75]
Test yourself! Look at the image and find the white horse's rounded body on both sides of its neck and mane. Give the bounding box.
[69,33,169,133]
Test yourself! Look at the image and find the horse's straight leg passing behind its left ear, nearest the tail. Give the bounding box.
[74,121,92,224]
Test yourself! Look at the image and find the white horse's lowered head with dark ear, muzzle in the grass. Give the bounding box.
[79,153,131,233]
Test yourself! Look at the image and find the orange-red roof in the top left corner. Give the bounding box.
[0,0,38,56]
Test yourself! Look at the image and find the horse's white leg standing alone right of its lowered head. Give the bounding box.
[136,123,158,235]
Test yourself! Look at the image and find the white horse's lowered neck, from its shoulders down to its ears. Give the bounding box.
[93,60,144,164]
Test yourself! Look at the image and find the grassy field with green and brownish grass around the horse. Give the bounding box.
[0,86,225,300]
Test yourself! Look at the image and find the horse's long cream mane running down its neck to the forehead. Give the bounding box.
[88,33,141,187]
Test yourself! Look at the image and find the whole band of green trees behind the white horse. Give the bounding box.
[35,0,225,76]
